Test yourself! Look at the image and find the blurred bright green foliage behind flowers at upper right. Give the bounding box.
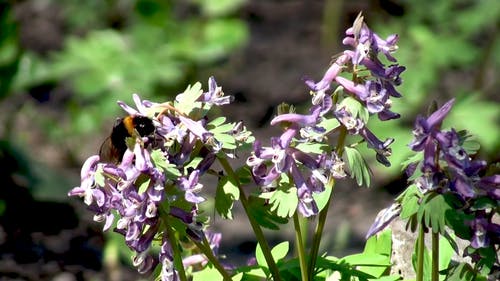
[365,0,500,179]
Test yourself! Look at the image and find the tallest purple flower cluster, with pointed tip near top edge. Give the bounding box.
[306,15,405,166]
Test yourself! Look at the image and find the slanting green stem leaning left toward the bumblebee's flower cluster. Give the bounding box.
[218,158,281,281]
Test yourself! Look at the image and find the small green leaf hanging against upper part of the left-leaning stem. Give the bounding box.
[215,176,240,219]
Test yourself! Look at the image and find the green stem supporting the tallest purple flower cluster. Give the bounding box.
[307,127,347,280]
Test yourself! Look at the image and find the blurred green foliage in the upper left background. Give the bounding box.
[0,0,248,148]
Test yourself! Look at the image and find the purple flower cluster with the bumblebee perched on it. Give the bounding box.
[68,78,238,280]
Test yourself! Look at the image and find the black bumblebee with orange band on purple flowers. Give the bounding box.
[99,115,155,163]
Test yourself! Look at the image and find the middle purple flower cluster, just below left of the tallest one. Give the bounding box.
[247,106,345,217]
